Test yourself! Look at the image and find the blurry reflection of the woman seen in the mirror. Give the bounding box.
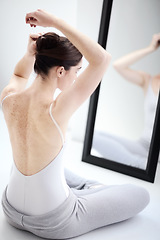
[93,34,160,169]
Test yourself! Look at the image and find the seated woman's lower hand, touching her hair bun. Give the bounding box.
[27,33,42,55]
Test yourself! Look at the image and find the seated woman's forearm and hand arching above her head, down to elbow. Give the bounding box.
[26,9,110,65]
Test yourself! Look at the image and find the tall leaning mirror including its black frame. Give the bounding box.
[82,0,160,182]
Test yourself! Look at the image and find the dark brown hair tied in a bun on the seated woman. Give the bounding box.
[34,32,82,75]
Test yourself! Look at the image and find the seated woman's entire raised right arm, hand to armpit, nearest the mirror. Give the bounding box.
[26,9,111,118]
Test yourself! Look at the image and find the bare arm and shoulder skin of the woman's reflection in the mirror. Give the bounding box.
[114,33,160,95]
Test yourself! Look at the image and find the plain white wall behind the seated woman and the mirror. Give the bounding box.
[0,0,102,141]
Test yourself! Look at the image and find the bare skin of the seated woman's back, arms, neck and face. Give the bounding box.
[1,10,110,176]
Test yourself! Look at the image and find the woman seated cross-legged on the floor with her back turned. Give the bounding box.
[1,9,149,239]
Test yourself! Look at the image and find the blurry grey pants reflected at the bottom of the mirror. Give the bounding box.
[92,131,149,169]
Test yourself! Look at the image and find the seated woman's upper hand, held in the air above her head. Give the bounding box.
[26,9,58,27]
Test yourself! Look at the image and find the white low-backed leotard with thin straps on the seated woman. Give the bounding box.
[2,95,69,215]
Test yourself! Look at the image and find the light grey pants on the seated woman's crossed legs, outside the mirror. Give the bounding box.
[2,171,149,239]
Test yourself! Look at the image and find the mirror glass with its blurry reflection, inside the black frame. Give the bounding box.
[91,0,160,169]
